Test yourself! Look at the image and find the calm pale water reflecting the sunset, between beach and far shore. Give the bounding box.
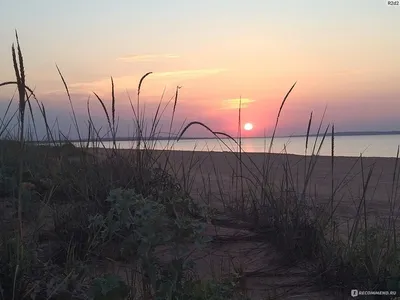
[77,135,400,157]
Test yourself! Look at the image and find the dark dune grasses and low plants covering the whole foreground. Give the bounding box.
[0,31,400,300]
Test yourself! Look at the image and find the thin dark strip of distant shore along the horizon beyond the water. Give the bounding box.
[40,131,400,143]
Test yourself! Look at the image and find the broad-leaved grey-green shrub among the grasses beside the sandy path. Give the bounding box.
[90,189,211,299]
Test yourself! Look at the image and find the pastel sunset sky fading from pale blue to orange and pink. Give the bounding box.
[0,0,400,136]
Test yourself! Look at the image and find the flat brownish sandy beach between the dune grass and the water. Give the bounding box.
[93,150,398,232]
